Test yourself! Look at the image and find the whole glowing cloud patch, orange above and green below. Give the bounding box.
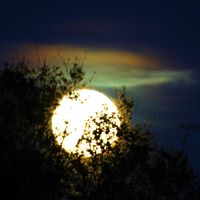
[9,45,195,87]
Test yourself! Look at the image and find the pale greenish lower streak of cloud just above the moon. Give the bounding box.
[86,66,192,87]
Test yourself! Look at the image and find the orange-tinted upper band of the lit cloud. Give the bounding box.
[17,45,163,69]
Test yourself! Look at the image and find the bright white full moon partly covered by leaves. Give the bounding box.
[52,89,120,157]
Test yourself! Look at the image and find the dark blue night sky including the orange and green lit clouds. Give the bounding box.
[0,0,200,172]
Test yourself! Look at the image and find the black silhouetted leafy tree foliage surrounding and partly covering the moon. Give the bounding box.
[0,59,200,200]
